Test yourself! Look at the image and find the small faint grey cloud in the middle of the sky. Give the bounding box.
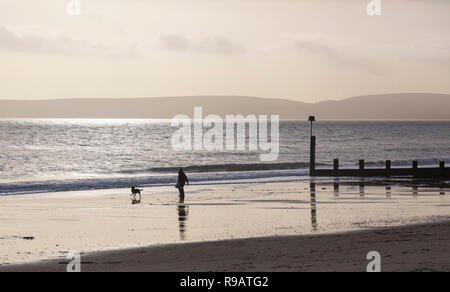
[159,34,245,55]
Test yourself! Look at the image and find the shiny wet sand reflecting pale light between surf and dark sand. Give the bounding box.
[0,178,450,264]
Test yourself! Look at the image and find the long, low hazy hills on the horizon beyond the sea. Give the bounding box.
[0,93,450,120]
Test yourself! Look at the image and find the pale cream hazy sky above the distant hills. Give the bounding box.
[0,0,450,102]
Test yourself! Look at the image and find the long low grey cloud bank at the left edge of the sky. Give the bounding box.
[0,25,138,58]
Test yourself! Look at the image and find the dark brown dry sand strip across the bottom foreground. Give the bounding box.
[0,220,450,272]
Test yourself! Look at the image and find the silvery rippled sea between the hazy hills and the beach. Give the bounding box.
[0,120,450,195]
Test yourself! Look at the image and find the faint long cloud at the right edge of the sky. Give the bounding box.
[282,32,450,65]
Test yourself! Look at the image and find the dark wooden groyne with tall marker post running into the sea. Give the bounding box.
[309,117,450,179]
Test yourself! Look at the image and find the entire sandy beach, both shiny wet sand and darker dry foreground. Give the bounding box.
[0,178,450,271]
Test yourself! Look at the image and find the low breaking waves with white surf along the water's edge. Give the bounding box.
[0,158,450,195]
